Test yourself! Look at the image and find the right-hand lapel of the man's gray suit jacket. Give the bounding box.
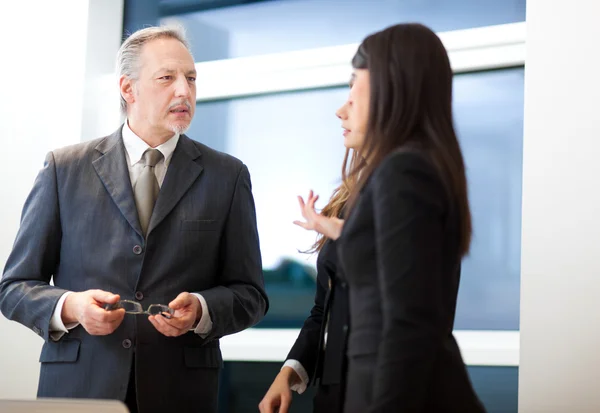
[148,135,204,235]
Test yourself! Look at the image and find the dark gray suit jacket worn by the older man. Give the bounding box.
[0,129,268,412]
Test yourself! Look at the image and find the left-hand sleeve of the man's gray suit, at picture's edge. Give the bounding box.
[0,152,67,341]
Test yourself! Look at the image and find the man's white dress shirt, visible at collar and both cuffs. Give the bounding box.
[50,122,212,341]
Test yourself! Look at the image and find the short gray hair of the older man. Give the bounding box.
[117,26,192,114]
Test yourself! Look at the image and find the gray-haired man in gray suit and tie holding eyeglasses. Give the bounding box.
[0,28,268,413]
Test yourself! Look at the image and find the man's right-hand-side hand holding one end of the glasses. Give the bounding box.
[148,293,202,337]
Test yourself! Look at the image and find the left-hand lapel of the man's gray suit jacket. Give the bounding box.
[92,129,143,237]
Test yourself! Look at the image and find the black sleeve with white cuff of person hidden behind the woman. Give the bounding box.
[286,246,335,380]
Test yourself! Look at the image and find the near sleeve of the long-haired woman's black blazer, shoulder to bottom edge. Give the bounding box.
[371,153,448,413]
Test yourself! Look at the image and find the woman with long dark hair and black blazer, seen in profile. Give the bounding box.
[288,24,484,413]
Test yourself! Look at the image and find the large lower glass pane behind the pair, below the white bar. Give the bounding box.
[189,68,523,330]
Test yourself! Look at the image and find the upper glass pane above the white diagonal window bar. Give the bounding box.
[163,0,525,61]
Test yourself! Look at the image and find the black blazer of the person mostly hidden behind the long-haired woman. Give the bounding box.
[287,240,349,385]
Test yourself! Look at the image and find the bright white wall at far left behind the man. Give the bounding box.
[0,0,123,398]
